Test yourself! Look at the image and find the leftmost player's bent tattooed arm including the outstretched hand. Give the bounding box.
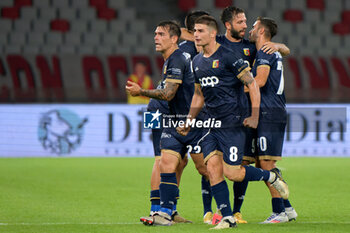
[125,81,180,101]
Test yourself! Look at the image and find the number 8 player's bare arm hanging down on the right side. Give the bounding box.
[238,71,260,129]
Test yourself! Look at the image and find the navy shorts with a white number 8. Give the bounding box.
[202,126,246,167]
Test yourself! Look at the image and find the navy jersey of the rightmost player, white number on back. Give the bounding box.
[252,50,286,122]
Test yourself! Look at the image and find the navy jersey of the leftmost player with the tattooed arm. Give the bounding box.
[162,49,194,119]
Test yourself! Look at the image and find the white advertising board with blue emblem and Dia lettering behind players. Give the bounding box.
[0,104,350,157]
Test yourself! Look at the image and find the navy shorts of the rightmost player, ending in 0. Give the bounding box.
[244,122,286,161]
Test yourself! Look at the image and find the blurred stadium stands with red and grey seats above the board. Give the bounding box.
[0,0,350,103]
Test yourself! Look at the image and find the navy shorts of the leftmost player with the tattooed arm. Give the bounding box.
[160,128,203,158]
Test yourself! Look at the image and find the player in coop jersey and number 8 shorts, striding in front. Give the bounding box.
[178,16,289,229]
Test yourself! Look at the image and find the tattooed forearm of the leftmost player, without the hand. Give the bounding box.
[141,82,180,101]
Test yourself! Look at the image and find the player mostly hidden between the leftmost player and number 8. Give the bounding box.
[179,11,213,224]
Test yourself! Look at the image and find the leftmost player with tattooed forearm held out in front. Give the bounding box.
[126,21,202,226]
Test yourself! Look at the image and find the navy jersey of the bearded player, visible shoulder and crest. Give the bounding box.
[216,35,256,66]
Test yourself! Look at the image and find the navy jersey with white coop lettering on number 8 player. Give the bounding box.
[192,46,250,127]
